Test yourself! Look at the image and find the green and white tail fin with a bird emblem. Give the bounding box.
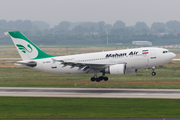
[8,31,54,60]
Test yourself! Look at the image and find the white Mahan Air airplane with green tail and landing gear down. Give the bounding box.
[6,31,176,82]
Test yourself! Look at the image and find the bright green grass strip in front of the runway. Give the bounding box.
[0,97,180,119]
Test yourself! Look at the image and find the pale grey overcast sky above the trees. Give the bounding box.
[0,0,180,27]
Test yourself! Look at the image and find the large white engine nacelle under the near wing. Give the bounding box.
[105,64,126,75]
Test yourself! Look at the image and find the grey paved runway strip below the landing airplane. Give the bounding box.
[0,87,180,99]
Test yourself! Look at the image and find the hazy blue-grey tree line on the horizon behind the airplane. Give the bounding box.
[0,20,180,45]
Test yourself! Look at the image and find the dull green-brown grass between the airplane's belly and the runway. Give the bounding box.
[0,68,180,89]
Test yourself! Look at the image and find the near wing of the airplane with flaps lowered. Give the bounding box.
[52,58,126,73]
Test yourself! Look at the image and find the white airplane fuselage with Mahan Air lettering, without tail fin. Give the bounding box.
[20,47,176,74]
